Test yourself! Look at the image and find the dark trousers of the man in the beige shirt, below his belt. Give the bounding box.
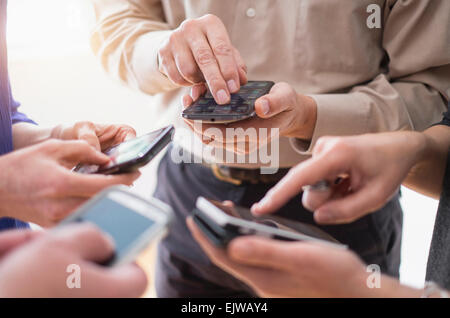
[155,149,403,297]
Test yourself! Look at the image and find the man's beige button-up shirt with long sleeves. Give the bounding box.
[92,0,450,167]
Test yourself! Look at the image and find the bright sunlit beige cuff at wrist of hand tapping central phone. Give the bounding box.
[131,30,178,95]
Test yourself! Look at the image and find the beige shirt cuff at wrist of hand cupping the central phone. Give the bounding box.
[289,93,370,155]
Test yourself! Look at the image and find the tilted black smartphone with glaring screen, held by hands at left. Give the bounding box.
[74,125,175,174]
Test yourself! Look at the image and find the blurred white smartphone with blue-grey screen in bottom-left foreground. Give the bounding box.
[58,186,173,266]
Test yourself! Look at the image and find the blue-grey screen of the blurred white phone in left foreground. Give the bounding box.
[75,193,156,262]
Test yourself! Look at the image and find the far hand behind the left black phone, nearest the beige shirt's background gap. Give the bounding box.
[51,121,136,151]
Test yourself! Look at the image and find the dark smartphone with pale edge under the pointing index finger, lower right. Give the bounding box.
[193,197,347,248]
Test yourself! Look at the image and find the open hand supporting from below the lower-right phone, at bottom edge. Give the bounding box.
[188,219,370,298]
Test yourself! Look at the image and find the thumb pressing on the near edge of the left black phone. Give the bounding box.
[52,140,110,168]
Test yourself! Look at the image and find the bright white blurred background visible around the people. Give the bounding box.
[8,0,437,296]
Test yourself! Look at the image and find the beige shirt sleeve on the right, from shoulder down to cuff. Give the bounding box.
[291,0,450,154]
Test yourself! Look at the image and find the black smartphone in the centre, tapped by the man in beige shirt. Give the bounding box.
[182,81,274,124]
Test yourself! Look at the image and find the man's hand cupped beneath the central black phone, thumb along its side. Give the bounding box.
[183,83,317,153]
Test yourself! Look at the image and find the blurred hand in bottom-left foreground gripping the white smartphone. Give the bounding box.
[0,224,147,297]
